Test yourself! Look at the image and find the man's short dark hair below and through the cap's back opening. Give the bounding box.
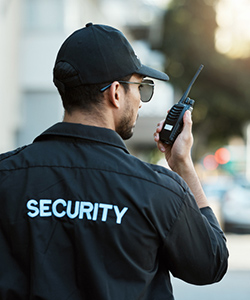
[54,62,131,113]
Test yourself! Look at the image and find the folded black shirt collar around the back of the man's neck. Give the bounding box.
[34,122,129,153]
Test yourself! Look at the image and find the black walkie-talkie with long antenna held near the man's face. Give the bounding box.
[160,65,204,145]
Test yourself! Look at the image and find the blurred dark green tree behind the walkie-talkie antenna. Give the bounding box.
[158,0,250,158]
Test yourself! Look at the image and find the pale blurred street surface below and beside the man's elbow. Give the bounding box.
[172,234,250,300]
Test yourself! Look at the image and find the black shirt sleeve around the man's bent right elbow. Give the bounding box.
[161,192,228,285]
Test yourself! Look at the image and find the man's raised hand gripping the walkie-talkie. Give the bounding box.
[154,110,193,173]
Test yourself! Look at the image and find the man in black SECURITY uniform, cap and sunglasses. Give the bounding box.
[0,23,228,300]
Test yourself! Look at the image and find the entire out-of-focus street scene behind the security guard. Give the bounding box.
[0,0,250,300]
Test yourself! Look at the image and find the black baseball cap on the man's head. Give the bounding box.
[54,23,169,87]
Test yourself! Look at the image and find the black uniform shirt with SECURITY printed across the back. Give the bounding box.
[0,123,228,300]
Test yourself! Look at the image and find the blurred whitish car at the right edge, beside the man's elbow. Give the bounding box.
[221,182,250,233]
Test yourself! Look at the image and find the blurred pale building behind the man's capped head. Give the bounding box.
[0,0,173,152]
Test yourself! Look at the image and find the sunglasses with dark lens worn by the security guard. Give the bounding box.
[100,79,155,102]
